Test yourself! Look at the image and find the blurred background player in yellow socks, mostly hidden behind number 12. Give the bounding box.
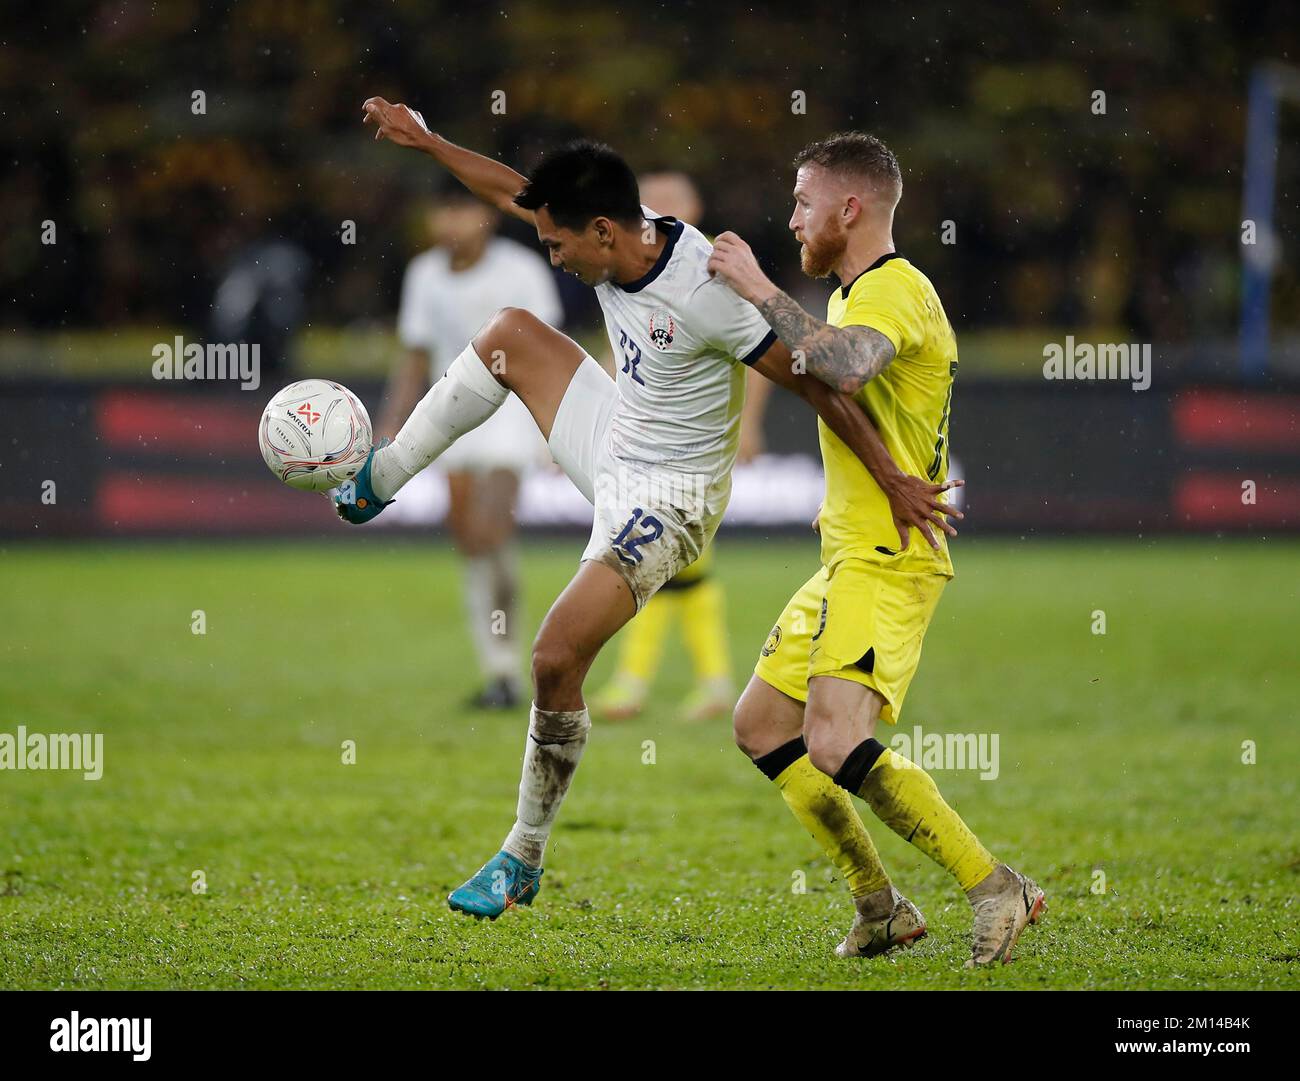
[592,173,772,721]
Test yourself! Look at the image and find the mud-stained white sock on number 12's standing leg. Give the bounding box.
[502,703,592,868]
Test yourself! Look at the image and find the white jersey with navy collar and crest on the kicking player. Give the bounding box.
[595,207,776,482]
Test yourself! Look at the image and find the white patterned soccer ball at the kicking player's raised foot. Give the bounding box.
[257,379,374,491]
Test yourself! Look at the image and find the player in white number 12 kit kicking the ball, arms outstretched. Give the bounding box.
[337,97,961,919]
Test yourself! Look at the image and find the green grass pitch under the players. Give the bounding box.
[0,537,1300,989]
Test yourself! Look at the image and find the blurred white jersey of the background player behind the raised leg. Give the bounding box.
[398,236,564,382]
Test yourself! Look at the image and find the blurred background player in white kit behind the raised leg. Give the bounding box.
[377,188,563,709]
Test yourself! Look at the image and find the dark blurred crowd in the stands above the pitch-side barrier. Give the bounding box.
[0,0,1300,343]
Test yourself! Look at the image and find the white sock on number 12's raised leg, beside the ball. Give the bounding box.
[371,346,510,499]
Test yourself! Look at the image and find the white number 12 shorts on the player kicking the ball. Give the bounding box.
[549,357,729,612]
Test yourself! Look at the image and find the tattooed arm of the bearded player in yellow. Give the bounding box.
[709,233,894,394]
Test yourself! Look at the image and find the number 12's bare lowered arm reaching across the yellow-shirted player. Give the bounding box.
[754,342,965,551]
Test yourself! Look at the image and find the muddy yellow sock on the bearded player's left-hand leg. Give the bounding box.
[758,739,889,898]
